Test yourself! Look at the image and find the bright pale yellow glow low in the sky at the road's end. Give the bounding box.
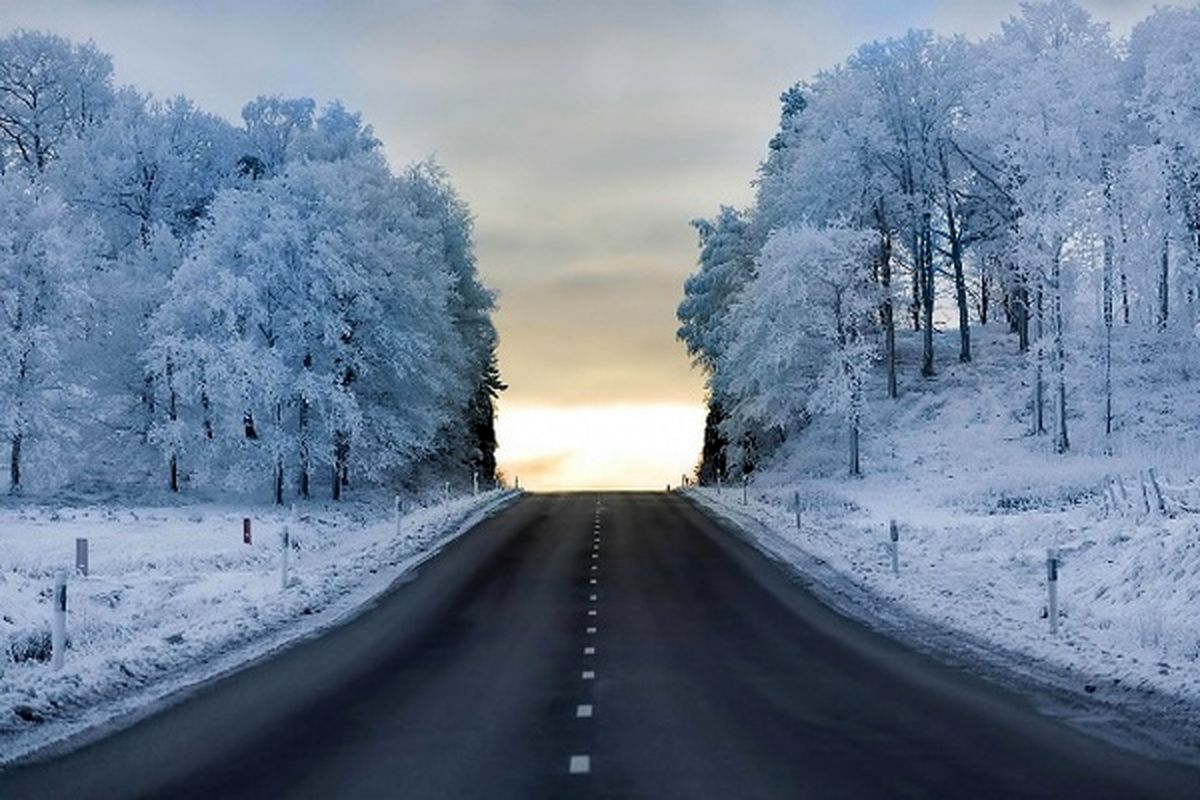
[497,404,704,491]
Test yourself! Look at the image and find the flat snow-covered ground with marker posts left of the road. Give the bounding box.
[0,492,514,764]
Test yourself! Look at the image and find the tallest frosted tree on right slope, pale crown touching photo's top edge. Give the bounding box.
[968,0,1121,452]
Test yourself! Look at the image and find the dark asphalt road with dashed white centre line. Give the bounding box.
[0,493,1200,800]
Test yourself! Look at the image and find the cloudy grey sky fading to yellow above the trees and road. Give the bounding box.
[0,0,1153,489]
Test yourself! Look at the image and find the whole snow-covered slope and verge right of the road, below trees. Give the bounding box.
[691,331,1200,754]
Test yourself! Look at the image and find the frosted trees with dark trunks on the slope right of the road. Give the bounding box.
[678,0,1200,481]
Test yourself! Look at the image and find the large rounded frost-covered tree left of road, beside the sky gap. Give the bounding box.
[146,110,475,503]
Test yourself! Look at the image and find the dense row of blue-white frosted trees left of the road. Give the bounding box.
[0,31,504,503]
